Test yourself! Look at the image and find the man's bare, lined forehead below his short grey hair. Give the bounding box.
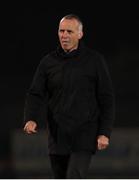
[59,19,79,29]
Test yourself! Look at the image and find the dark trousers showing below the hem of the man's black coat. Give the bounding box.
[50,152,92,179]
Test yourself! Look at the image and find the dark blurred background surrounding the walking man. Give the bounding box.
[0,1,139,178]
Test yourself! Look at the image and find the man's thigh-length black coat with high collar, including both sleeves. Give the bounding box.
[25,41,114,154]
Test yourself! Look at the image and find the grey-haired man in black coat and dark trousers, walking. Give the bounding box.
[24,14,114,179]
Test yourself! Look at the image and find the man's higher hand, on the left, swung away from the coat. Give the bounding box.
[24,120,37,134]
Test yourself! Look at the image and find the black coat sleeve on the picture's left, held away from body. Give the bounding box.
[24,59,47,124]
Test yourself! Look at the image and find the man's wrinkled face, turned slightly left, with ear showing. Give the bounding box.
[58,19,83,52]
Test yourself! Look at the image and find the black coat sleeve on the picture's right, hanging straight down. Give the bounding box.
[97,52,115,138]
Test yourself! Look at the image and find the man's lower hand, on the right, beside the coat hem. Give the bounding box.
[97,135,109,150]
